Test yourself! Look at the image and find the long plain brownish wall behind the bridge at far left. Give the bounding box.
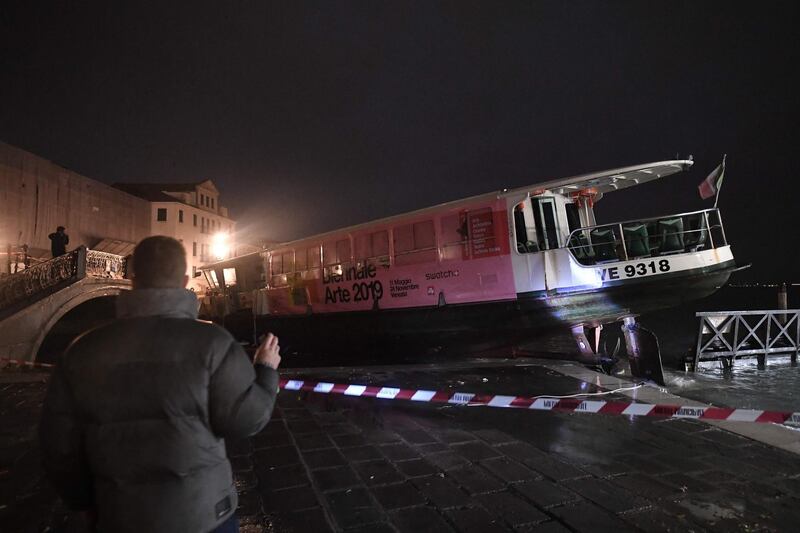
[0,142,151,262]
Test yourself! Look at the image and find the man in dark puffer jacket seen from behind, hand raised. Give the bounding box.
[40,237,280,533]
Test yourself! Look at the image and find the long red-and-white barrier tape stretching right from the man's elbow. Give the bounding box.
[280,379,800,425]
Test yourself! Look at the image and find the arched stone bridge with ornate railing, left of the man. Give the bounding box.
[0,247,130,362]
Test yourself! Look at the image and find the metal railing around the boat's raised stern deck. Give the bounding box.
[567,208,728,265]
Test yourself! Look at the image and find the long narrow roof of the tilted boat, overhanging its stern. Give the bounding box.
[206,159,694,256]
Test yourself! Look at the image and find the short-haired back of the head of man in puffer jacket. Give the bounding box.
[131,235,186,289]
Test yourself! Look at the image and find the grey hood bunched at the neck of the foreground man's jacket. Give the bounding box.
[117,289,198,319]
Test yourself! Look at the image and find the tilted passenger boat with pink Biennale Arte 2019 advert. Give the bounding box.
[201,160,736,383]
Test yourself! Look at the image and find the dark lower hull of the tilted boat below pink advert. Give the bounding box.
[217,262,735,363]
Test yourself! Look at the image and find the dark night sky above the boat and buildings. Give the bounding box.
[0,0,800,281]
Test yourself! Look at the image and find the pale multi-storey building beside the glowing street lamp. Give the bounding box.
[115,180,236,290]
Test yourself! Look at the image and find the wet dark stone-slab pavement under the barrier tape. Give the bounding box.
[0,361,800,532]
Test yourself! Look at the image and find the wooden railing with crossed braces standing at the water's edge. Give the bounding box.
[690,309,800,370]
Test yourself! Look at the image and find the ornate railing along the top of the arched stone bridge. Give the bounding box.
[0,246,126,320]
